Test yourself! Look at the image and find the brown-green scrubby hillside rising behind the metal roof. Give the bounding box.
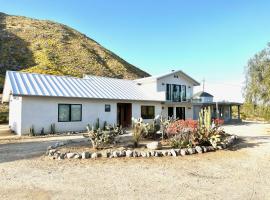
[0,13,149,88]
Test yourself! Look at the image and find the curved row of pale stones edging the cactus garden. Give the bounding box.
[46,135,238,160]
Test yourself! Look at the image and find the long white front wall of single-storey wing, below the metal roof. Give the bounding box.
[16,96,161,134]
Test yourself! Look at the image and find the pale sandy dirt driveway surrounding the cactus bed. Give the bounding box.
[0,123,270,200]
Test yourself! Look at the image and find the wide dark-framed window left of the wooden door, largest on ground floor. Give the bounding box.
[58,104,82,122]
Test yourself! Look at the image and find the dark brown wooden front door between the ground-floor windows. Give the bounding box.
[117,103,132,127]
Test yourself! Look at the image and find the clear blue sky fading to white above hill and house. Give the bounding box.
[0,0,270,101]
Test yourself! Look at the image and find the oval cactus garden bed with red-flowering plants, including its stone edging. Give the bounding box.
[46,108,237,160]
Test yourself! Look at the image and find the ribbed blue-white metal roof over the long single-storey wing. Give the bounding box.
[3,71,160,101]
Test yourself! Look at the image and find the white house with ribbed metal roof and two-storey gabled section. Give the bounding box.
[2,70,240,135]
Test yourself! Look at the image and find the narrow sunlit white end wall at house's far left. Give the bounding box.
[9,95,22,135]
